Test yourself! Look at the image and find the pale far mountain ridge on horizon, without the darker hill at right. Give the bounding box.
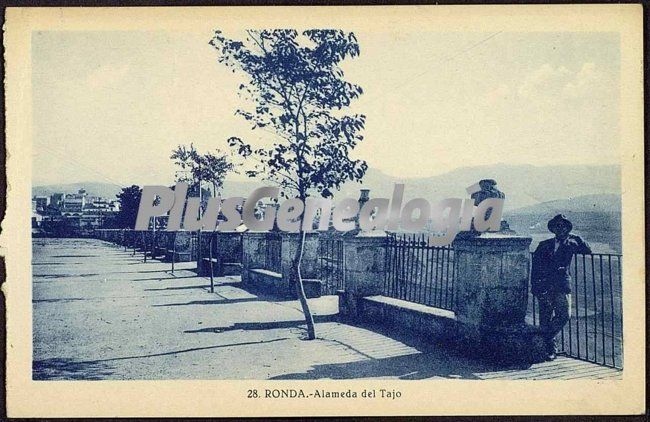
[32,164,621,212]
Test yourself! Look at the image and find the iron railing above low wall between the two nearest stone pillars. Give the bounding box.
[384,234,456,310]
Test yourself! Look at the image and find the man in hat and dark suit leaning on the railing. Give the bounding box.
[531,214,591,360]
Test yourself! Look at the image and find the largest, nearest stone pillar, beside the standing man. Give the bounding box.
[453,233,544,362]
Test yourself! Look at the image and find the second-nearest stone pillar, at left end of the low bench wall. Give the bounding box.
[339,232,388,318]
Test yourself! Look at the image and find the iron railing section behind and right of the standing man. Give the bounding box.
[527,254,623,368]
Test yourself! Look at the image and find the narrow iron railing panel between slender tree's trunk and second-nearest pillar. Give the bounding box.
[318,235,345,295]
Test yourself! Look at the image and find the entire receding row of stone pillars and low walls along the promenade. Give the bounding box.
[96,230,544,361]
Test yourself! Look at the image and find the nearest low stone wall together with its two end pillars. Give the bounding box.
[339,233,546,362]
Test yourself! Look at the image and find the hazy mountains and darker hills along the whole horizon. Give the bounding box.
[32,165,621,252]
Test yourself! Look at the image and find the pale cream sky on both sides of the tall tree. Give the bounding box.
[32,28,620,186]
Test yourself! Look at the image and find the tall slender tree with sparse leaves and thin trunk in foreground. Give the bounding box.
[210,29,368,339]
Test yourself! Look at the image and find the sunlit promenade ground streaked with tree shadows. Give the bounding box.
[32,239,621,380]
